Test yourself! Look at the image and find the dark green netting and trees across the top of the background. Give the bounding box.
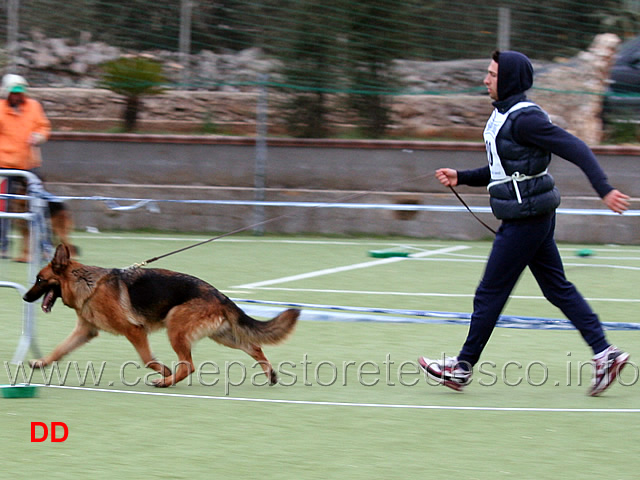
[0,0,640,95]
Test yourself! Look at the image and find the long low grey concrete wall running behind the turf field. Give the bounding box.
[42,138,640,244]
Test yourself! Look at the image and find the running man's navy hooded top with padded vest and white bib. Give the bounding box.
[458,51,613,220]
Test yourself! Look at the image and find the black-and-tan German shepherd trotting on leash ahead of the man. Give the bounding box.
[24,244,300,387]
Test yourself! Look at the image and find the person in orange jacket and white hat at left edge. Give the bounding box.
[0,74,51,262]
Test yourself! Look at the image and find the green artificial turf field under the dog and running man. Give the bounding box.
[0,233,640,480]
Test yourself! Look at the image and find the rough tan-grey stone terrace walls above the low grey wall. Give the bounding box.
[22,34,619,145]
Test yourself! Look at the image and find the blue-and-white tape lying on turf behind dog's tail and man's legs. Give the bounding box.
[233,299,640,331]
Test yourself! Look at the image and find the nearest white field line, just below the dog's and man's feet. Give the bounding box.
[34,384,640,413]
